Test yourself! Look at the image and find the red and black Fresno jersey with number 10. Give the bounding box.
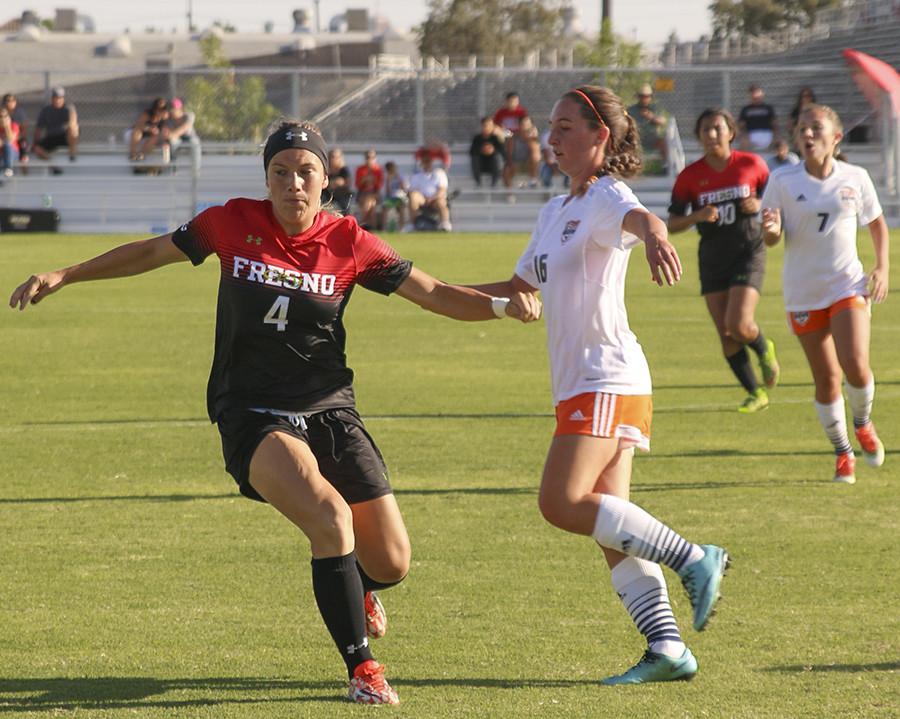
[669,150,769,264]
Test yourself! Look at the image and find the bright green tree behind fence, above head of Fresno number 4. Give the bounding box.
[185,35,278,142]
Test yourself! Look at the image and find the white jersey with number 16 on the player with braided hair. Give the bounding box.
[516,177,651,404]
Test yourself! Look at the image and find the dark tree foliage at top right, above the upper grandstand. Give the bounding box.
[709,0,840,37]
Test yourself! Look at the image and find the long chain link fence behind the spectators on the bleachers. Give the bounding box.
[0,64,878,145]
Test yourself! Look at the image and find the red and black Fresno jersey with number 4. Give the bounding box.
[172,198,412,422]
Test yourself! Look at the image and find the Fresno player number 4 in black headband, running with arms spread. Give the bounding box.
[9,121,540,704]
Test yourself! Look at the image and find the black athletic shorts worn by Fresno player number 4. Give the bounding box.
[217,407,393,504]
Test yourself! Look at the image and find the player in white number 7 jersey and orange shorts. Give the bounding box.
[762,105,889,484]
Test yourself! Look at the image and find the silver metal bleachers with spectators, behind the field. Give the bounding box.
[0,140,900,235]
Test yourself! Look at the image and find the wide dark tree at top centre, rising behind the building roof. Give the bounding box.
[416,0,563,58]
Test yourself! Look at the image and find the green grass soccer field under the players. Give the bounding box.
[0,233,900,719]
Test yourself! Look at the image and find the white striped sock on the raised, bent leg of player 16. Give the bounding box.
[591,494,703,572]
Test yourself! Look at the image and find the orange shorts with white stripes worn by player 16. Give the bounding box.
[553,392,653,450]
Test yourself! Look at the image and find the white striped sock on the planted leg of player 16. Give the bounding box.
[610,557,684,657]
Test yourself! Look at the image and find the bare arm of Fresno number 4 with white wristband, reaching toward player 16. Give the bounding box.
[397,267,541,322]
